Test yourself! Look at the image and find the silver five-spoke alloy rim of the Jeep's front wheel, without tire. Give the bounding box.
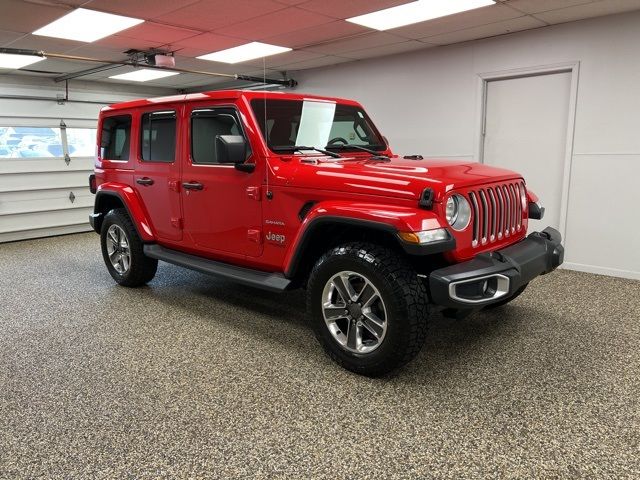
[322,271,387,353]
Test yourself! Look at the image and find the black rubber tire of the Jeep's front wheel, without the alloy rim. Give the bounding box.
[307,243,429,377]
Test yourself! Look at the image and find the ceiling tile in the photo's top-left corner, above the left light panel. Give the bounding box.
[0,0,71,32]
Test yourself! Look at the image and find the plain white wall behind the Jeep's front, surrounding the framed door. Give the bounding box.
[294,12,640,279]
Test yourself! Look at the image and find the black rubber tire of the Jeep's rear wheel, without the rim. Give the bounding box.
[100,208,158,287]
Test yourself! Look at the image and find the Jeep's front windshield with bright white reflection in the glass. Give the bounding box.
[251,99,386,151]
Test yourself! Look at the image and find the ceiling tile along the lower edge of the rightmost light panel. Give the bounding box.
[388,1,522,39]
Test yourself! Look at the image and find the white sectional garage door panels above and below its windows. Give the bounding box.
[0,75,175,246]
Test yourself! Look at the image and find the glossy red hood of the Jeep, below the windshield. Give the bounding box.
[274,155,521,201]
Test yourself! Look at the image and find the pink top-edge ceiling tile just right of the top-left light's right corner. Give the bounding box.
[154,0,286,31]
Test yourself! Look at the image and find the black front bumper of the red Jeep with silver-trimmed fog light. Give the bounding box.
[429,227,564,309]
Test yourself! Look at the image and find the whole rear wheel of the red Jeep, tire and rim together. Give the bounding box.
[100,208,158,287]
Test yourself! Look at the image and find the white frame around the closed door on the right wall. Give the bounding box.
[474,61,580,242]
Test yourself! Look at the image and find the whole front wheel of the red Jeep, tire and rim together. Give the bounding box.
[307,243,428,376]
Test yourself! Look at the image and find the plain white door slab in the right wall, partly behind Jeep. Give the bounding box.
[483,72,571,231]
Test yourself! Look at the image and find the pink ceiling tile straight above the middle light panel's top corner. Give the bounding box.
[215,7,332,40]
